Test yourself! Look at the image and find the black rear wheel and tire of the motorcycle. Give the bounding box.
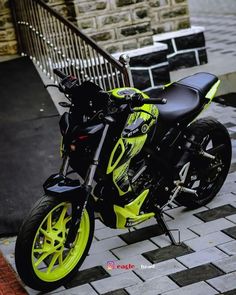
[176,117,232,209]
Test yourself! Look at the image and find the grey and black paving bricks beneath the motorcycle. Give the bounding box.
[0,100,236,295]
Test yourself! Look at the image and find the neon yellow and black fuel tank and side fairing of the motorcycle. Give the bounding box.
[106,87,158,196]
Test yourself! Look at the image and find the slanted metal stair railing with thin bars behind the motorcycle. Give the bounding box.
[12,0,133,90]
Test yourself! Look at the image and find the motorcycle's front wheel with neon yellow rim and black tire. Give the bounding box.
[15,196,94,292]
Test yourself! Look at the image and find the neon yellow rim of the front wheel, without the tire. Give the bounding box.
[31,202,90,282]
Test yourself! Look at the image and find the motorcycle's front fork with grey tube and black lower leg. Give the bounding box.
[64,121,113,248]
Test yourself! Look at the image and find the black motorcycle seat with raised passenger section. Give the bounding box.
[157,73,218,124]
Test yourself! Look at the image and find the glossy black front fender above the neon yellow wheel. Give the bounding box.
[43,174,84,199]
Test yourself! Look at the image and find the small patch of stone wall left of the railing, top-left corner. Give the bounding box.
[0,0,17,56]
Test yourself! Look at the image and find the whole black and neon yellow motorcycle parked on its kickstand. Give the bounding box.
[15,69,231,291]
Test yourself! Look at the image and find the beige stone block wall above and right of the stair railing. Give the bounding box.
[47,0,189,53]
